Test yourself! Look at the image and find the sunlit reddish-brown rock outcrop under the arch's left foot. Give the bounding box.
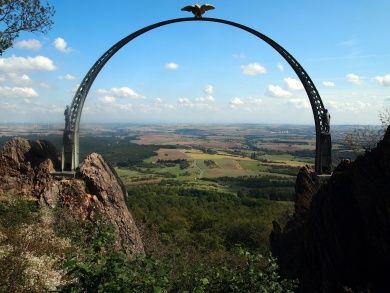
[0,138,144,255]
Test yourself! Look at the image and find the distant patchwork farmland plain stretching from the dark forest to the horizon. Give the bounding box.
[0,124,352,198]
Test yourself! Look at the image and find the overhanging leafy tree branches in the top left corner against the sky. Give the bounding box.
[0,0,55,55]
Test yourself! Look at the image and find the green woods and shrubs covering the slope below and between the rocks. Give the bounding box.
[0,186,296,292]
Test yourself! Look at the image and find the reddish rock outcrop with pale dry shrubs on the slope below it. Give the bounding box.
[0,138,144,292]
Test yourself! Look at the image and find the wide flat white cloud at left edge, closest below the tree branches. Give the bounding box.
[0,56,56,72]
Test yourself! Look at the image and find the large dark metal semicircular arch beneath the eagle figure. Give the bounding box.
[62,17,331,174]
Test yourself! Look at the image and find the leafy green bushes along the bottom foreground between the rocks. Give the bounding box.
[61,216,296,292]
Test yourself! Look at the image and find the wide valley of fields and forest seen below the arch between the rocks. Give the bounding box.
[0,121,366,286]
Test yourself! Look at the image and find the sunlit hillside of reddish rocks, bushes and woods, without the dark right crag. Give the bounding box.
[0,139,295,292]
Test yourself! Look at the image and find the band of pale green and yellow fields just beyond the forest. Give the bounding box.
[118,148,311,184]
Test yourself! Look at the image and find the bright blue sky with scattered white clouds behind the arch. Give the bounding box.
[0,0,390,124]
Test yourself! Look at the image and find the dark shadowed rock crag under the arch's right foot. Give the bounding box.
[271,127,390,292]
